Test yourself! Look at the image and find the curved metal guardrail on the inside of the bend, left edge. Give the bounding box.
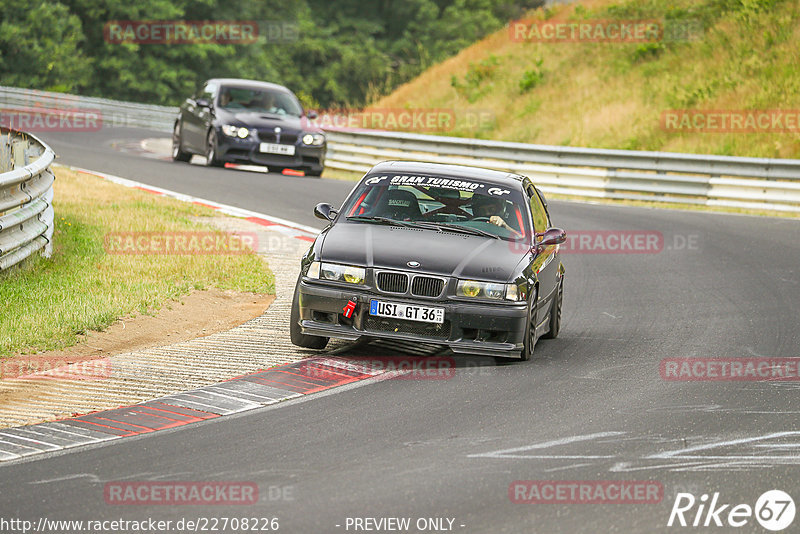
[0,129,55,271]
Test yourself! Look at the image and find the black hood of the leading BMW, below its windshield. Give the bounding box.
[320,223,527,282]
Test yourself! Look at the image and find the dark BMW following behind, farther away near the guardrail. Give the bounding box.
[172,78,326,176]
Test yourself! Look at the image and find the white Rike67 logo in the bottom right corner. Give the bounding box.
[667,490,795,532]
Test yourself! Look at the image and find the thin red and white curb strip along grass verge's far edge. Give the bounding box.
[53,165,320,241]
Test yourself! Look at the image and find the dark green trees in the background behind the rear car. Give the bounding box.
[0,0,543,107]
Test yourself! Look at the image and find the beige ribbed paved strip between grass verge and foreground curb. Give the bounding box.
[0,217,356,428]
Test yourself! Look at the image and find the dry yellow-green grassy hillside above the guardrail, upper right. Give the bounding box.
[373,0,800,158]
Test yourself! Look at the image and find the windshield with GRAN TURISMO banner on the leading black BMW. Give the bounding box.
[342,174,530,240]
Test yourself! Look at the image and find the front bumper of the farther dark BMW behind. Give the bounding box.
[217,133,326,172]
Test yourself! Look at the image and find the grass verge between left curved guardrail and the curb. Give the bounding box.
[0,169,275,357]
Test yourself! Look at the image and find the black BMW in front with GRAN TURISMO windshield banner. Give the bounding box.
[290,161,566,360]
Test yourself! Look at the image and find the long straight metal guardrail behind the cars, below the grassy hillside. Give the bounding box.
[6,87,800,212]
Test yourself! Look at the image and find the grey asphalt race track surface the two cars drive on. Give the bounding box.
[0,126,800,533]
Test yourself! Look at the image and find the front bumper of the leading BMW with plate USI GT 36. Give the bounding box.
[298,280,528,357]
